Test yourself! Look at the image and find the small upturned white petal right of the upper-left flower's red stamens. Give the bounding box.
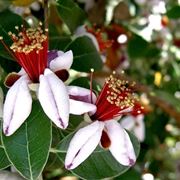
[49,51,73,72]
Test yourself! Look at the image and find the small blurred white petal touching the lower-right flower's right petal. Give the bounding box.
[120,116,135,130]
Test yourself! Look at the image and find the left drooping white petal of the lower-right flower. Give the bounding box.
[65,121,104,169]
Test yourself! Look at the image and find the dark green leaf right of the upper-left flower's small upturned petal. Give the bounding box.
[65,36,103,72]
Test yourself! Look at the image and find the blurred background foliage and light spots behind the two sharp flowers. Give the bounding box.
[0,0,180,180]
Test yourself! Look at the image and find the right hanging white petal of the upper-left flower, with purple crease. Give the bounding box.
[38,69,69,129]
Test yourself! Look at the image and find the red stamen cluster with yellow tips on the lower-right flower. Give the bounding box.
[91,75,136,121]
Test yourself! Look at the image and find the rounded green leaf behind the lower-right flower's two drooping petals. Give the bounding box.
[58,129,140,179]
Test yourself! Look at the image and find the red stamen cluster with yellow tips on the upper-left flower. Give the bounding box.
[1,26,48,83]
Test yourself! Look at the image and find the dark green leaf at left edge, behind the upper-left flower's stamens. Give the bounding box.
[0,10,23,60]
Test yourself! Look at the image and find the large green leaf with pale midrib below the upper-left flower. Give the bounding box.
[2,101,52,180]
